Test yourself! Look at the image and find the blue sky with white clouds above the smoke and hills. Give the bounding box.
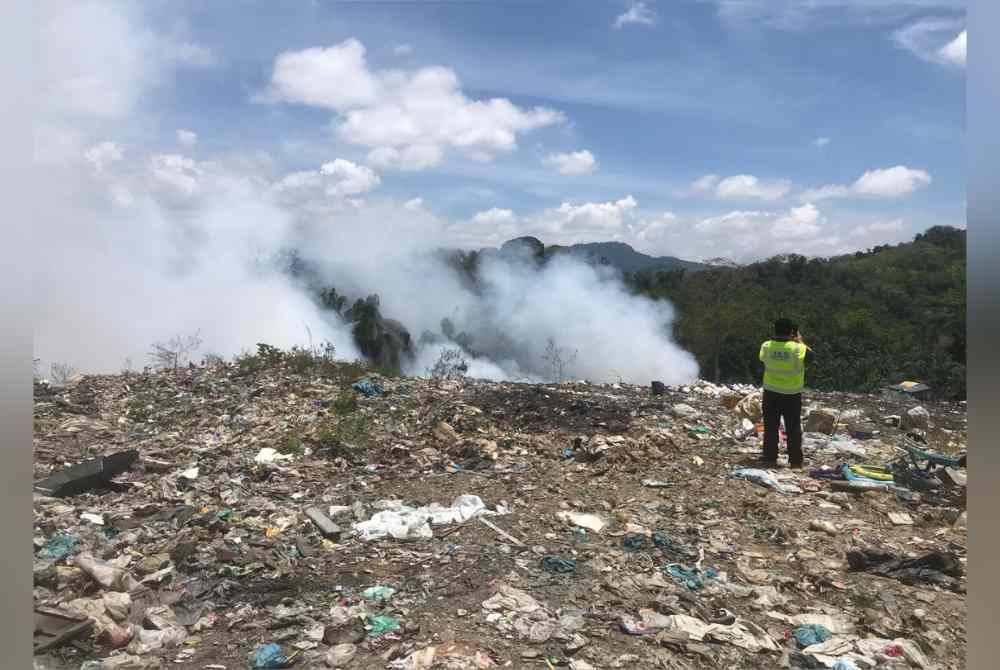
[40,0,965,260]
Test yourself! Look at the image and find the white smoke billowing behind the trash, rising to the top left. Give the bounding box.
[34,2,697,383]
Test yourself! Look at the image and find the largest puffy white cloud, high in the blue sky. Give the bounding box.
[260,39,565,170]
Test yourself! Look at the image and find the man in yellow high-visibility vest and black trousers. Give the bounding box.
[759,319,810,468]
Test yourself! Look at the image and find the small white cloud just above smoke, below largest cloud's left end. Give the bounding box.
[271,158,381,211]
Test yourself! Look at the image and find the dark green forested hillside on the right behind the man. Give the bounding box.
[626,226,966,399]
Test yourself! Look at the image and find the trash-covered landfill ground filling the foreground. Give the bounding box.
[34,362,967,670]
